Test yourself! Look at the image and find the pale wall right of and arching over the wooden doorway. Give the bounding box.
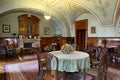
[76,13,120,37]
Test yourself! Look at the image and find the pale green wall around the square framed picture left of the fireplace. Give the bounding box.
[0,15,19,37]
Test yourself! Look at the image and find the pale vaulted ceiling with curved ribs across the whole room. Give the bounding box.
[0,0,120,35]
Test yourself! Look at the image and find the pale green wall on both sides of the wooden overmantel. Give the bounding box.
[0,13,55,37]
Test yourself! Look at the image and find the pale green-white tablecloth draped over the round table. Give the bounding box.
[50,51,90,72]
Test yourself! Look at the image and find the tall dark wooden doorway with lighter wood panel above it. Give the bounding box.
[75,19,88,51]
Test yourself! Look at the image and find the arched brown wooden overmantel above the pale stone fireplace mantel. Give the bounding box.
[18,14,39,37]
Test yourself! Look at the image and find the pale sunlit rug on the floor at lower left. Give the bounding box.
[5,60,40,80]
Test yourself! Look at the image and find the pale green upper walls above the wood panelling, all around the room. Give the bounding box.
[0,13,120,37]
